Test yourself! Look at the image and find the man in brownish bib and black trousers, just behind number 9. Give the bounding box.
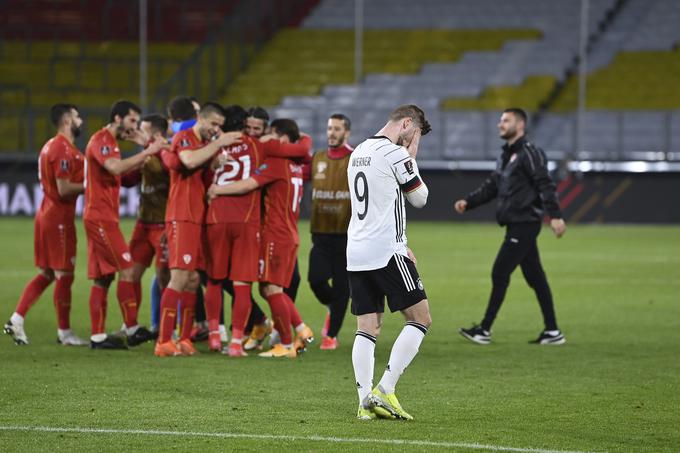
[308,114,352,350]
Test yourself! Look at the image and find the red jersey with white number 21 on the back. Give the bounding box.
[206,135,266,224]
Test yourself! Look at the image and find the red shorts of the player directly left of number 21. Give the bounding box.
[165,221,204,271]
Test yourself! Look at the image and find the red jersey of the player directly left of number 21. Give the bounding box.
[165,128,210,224]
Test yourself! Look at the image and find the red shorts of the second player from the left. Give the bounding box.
[83,220,132,279]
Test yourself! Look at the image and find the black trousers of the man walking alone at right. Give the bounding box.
[482,222,557,330]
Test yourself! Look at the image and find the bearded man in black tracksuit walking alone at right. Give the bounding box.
[454,108,566,344]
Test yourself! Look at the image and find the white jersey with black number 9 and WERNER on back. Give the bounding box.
[347,136,422,271]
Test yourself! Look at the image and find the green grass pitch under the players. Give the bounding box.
[0,218,680,452]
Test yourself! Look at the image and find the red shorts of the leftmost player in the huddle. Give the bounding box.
[33,215,76,272]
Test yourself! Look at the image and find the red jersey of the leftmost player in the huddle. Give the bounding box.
[38,134,85,223]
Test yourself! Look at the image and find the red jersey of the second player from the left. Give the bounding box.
[83,127,120,222]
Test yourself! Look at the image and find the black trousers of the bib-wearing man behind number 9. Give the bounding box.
[307,234,349,337]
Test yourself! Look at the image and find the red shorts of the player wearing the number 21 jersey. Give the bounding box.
[205,223,260,282]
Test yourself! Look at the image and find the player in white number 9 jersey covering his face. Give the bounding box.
[347,105,432,420]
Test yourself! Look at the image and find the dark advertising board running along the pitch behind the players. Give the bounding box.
[0,160,680,224]
